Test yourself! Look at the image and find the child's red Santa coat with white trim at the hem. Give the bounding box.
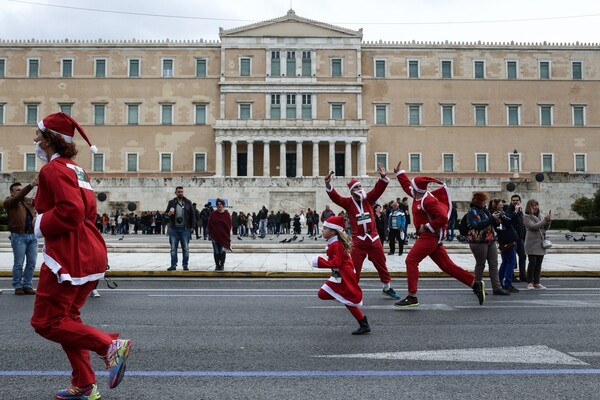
[312,236,362,307]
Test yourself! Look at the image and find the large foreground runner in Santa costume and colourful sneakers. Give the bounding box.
[31,113,131,400]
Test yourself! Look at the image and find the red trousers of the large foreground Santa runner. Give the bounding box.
[31,264,119,386]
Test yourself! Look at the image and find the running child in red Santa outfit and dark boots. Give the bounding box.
[312,216,371,335]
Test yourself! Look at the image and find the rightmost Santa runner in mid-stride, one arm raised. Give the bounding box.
[394,162,485,308]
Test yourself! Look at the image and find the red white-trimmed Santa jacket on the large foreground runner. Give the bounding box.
[35,157,107,285]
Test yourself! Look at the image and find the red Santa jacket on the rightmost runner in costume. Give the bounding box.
[396,170,451,242]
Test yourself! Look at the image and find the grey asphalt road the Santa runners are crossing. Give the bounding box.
[0,278,600,400]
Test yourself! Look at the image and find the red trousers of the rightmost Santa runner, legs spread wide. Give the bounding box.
[406,233,475,293]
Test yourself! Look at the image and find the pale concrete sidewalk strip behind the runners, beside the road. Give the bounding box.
[0,228,600,277]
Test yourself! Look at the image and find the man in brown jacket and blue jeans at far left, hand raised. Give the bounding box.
[4,178,38,295]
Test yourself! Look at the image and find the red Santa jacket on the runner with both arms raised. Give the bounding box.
[326,177,390,242]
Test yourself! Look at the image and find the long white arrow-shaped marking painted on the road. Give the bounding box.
[315,346,588,365]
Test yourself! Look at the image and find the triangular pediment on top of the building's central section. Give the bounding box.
[219,10,362,39]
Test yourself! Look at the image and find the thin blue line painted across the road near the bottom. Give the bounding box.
[0,369,600,377]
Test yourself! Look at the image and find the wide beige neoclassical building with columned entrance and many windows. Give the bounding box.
[0,10,600,217]
